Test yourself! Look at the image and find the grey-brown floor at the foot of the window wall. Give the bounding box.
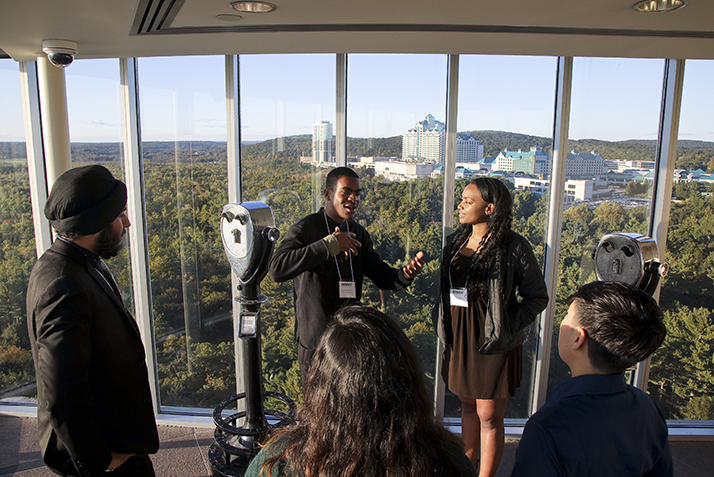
[0,414,714,477]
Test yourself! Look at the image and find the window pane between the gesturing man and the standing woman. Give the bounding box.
[347,55,447,396]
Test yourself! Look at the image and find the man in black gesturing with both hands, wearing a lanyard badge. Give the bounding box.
[269,167,424,383]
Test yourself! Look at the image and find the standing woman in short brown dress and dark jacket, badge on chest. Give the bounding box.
[435,178,548,477]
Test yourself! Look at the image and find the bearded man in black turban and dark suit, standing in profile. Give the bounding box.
[27,165,159,477]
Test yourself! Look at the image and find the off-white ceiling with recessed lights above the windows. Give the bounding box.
[0,0,714,61]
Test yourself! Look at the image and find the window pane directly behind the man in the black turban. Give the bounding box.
[65,59,134,312]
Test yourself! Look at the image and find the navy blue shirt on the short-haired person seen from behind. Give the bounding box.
[511,374,673,477]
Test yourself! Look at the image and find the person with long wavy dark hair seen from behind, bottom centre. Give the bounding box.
[245,306,477,477]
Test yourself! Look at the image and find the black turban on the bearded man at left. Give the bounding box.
[45,165,126,235]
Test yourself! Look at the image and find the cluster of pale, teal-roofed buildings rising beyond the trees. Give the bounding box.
[326,114,714,199]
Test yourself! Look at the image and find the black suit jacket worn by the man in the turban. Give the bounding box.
[27,240,159,477]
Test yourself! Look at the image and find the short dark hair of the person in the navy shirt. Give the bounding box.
[568,281,667,374]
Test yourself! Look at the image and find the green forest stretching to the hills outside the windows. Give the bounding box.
[0,132,714,419]
